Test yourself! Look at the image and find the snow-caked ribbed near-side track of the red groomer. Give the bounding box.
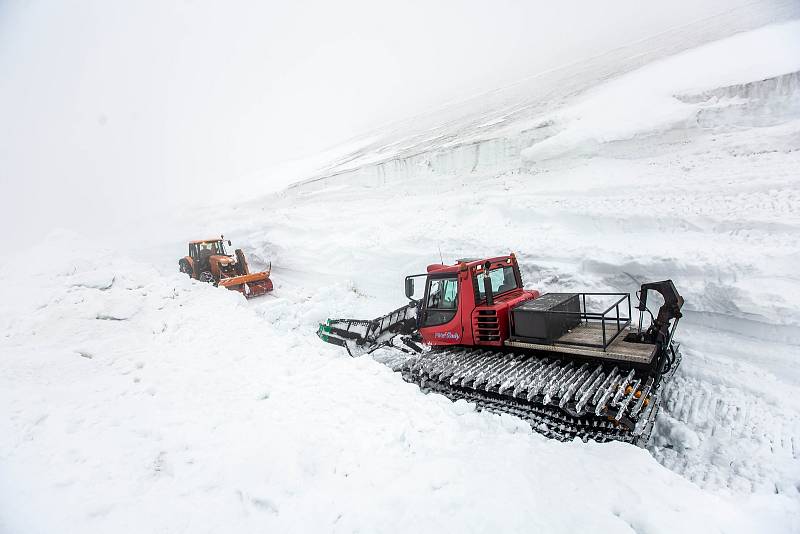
[400,348,680,446]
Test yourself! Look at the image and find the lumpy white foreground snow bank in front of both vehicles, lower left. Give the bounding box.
[0,234,800,533]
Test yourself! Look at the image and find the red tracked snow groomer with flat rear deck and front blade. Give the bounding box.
[317,254,683,446]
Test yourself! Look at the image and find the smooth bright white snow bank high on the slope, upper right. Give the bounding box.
[522,20,800,162]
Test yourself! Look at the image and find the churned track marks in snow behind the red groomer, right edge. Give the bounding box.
[650,375,800,498]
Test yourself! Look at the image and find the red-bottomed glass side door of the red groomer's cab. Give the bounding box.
[420,274,463,345]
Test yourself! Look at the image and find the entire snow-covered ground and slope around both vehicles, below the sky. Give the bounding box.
[0,20,800,533]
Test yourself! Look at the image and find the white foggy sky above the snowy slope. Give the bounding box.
[0,0,788,238]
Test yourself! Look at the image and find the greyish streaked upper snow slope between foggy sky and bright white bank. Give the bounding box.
[290,0,800,195]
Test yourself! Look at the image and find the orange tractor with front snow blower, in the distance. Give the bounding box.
[178,236,272,298]
